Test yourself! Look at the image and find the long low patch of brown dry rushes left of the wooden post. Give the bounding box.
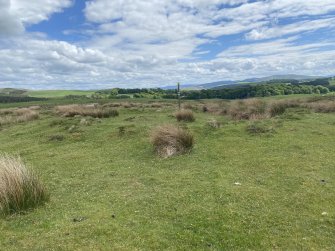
[55,105,119,118]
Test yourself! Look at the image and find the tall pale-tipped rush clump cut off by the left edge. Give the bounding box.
[0,154,49,216]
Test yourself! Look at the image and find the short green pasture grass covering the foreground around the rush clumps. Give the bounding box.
[0,101,335,250]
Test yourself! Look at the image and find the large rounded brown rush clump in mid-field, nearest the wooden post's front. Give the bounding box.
[151,125,194,157]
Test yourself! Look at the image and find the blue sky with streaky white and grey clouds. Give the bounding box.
[0,0,335,89]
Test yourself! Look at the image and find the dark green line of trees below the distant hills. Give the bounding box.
[92,79,335,99]
